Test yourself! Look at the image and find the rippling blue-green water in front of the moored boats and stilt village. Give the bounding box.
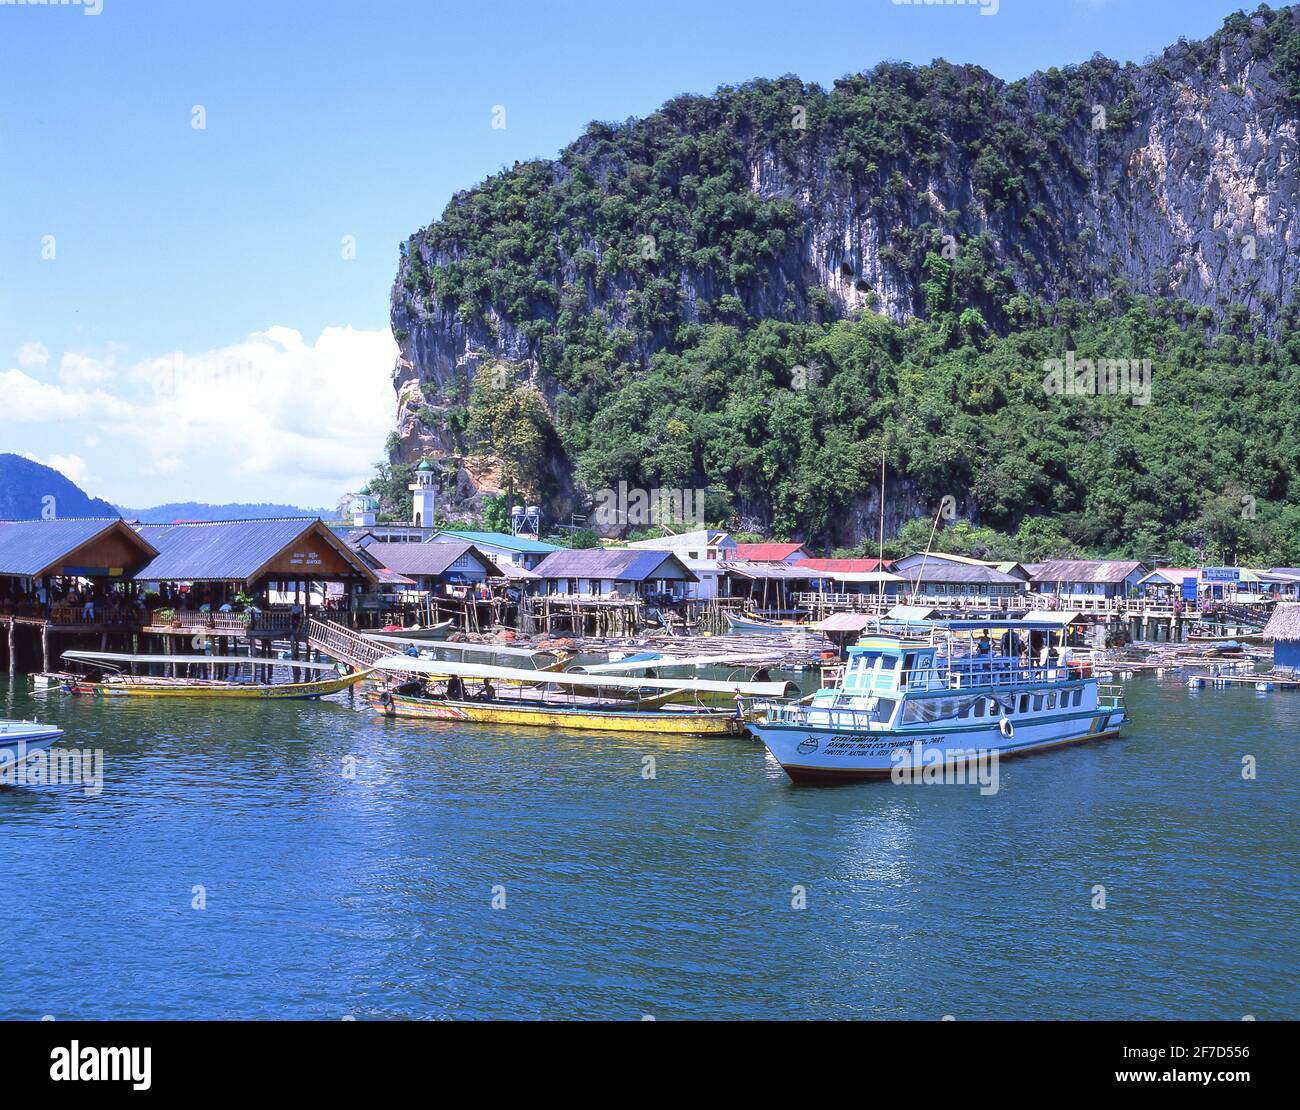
[0,677,1300,1020]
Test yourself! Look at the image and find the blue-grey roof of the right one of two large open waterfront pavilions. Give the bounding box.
[135,517,361,582]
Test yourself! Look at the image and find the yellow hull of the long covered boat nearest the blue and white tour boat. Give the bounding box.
[374,694,744,736]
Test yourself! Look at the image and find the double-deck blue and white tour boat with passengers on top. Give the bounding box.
[749,620,1126,782]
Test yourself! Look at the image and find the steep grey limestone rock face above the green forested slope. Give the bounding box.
[391,8,1300,525]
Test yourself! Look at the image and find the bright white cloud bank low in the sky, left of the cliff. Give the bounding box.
[0,326,397,507]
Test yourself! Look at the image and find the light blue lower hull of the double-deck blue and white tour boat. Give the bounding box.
[749,708,1126,782]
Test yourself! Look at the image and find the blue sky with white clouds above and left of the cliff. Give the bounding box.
[0,0,1255,506]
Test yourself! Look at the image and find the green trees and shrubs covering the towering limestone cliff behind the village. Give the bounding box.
[394,8,1300,564]
